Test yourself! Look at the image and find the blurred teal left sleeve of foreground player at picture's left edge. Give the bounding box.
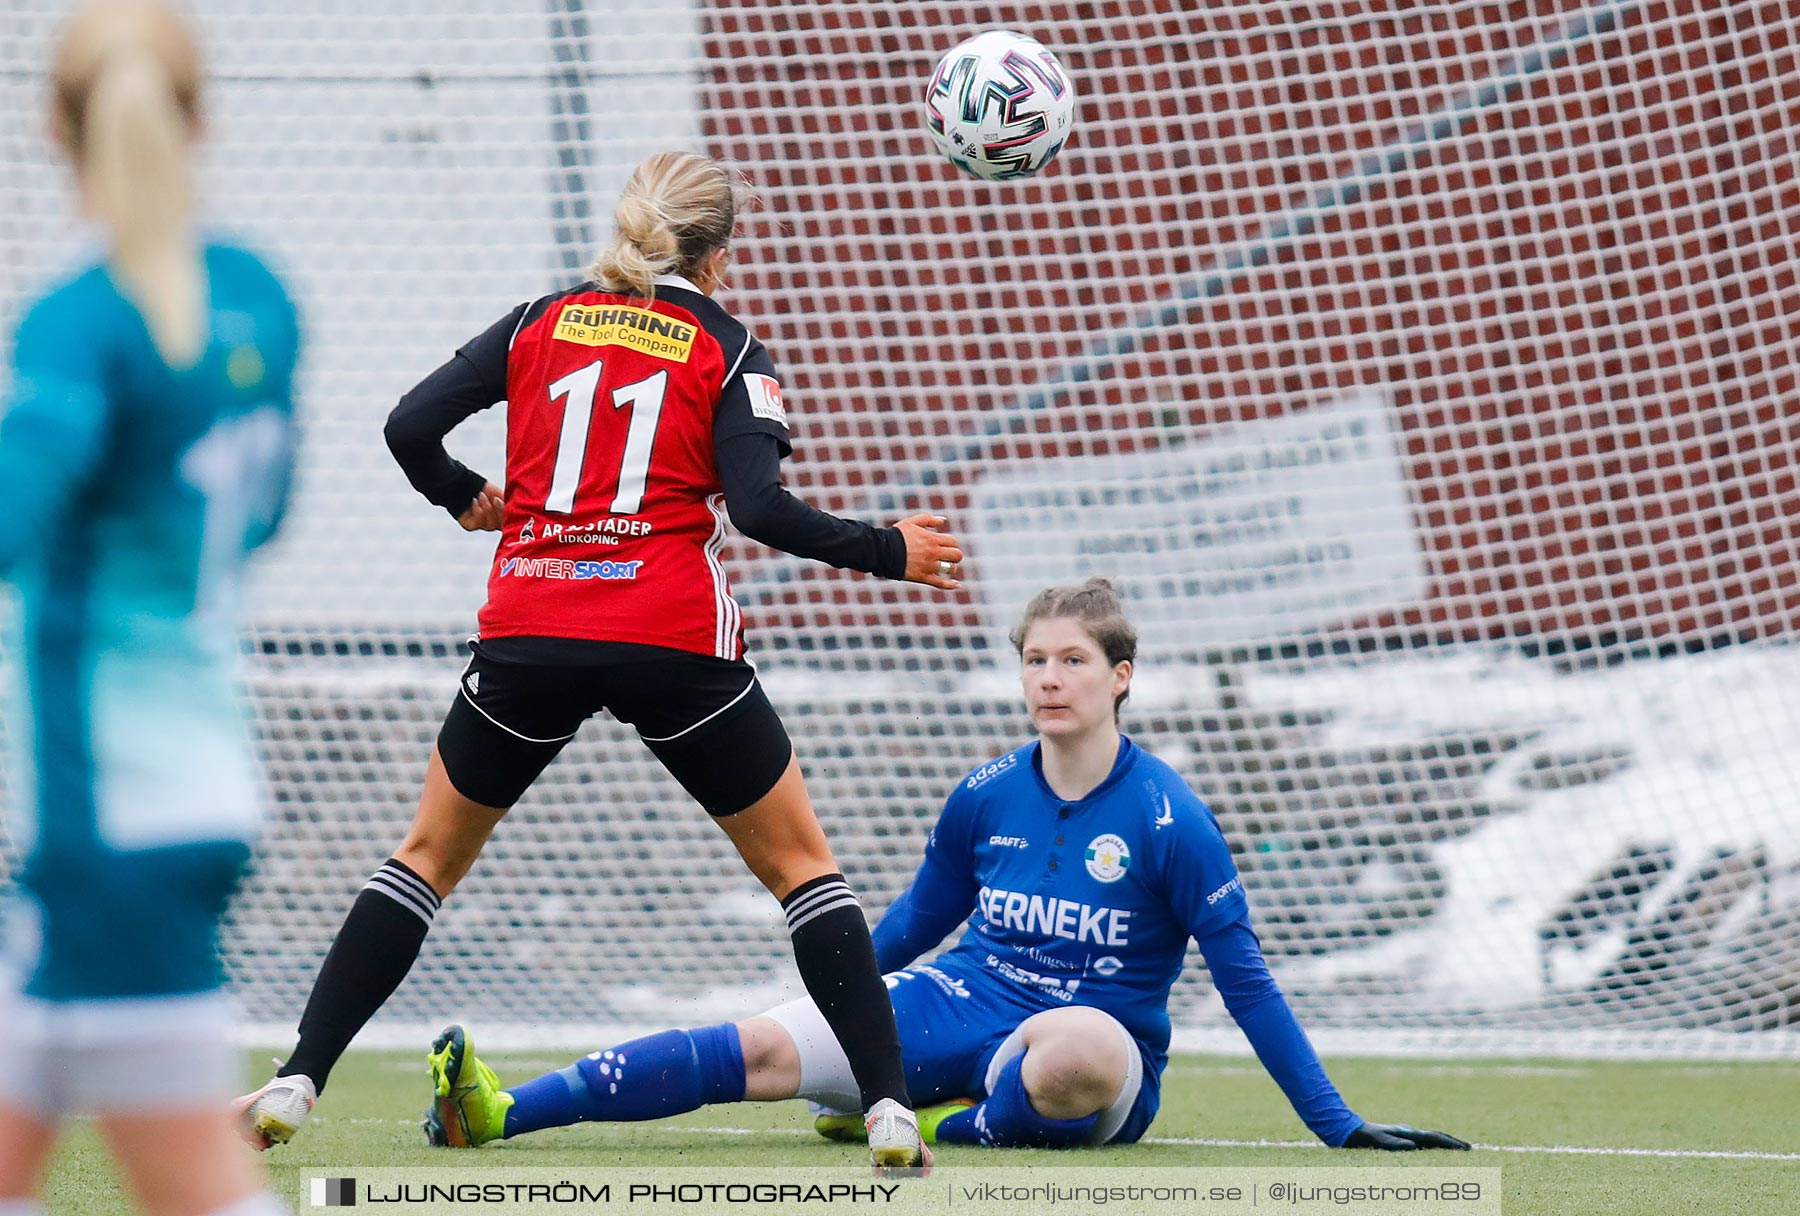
[0,295,110,576]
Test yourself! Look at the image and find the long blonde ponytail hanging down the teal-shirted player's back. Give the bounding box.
[81,47,207,367]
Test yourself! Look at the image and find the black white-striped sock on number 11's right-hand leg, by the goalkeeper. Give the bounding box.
[781,874,913,1110]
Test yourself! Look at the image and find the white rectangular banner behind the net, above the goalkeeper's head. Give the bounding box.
[968,392,1426,655]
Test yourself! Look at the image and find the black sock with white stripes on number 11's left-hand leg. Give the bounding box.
[277,858,441,1092]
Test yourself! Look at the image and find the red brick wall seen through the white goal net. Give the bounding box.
[704,0,1800,646]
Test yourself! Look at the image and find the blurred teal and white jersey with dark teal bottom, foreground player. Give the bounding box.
[0,245,299,1000]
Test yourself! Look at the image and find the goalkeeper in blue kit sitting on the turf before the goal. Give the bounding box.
[425,579,1469,1151]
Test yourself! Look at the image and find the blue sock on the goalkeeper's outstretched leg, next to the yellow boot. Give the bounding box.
[506,1022,743,1137]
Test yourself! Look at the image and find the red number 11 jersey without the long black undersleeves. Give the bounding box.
[464,286,788,658]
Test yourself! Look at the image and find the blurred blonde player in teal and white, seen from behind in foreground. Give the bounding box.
[0,0,299,1216]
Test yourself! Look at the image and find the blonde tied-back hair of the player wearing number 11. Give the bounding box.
[587,153,756,295]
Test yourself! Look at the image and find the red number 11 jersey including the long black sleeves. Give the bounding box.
[387,277,905,658]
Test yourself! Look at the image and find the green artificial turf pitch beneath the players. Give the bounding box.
[31,1047,1800,1216]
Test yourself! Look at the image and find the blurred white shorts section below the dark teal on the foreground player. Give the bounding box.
[0,970,243,1122]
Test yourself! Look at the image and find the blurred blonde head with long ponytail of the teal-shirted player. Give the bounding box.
[50,0,207,367]
